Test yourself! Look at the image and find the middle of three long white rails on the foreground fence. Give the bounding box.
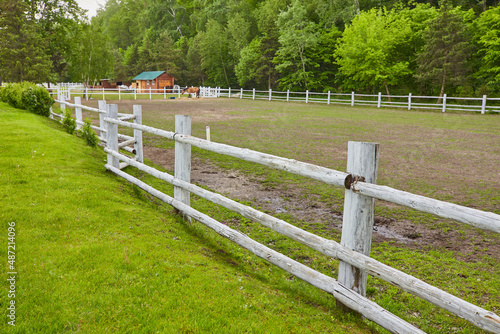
[105,149,500,333]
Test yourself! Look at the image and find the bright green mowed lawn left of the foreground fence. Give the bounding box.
[0,103,378,333]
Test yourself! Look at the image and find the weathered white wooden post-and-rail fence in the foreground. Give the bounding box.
[53,100,500,333]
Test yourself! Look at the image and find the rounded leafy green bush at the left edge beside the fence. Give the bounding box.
[0,82,54,116]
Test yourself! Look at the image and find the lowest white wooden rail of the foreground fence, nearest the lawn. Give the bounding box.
[106,164,424,334]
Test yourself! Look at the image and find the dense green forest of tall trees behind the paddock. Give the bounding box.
[0,0,500,96]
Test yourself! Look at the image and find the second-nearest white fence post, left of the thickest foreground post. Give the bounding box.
[174,115,191,219]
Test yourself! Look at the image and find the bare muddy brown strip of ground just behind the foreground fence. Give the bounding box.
[144,146,500,262]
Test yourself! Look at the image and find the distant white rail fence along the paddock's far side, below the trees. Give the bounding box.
[200,87,500,114]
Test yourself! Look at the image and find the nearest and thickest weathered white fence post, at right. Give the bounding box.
[338,141,379,296]
